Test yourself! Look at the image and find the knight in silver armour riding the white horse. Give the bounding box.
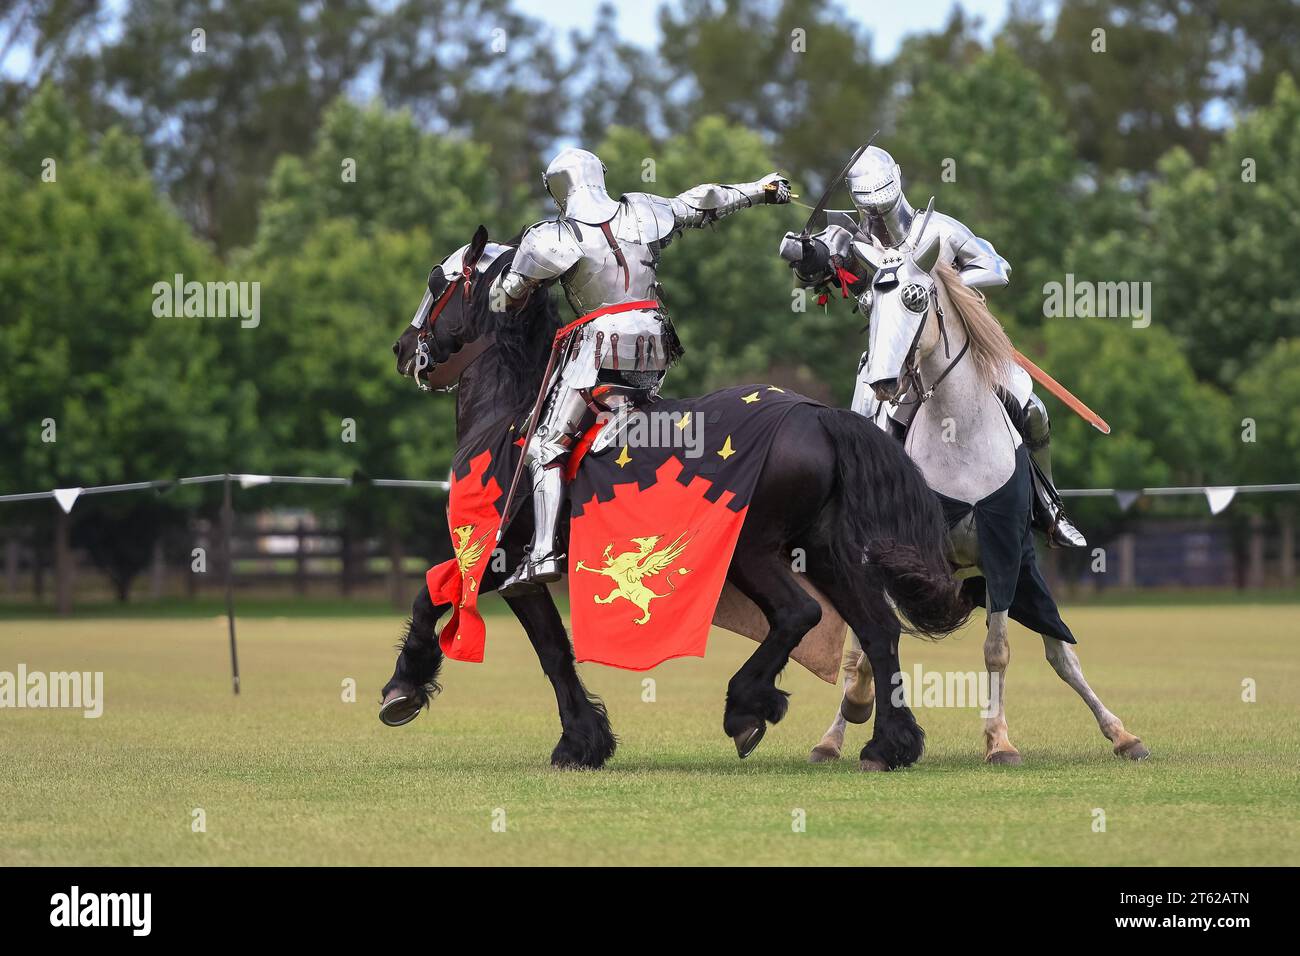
[780,146,1087,548]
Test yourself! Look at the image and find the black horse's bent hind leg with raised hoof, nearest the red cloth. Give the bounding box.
[723,548,822,758]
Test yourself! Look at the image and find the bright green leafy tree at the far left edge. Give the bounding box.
[0,86,259,592]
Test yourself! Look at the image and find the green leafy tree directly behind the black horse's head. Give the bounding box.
[241,100,509,587]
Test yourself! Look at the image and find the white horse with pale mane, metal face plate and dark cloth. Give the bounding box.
[810,229,1149,763]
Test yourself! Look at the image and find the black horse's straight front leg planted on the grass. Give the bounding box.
[506,588,618,770]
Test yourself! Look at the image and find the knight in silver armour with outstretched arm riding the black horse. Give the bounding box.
[490,150,789,594]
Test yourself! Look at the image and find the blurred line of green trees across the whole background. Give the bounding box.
[0,0,1300,598]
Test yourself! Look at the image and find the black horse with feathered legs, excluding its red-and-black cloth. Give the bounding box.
[384,226,970,770]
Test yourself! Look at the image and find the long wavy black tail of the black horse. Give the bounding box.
[819,408,971,639]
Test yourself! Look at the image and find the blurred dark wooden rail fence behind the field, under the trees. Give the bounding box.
[0,511,1296,613]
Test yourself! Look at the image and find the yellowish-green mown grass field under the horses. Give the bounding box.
[0,605,1300,865]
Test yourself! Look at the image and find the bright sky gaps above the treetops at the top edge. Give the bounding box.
[515,0,1009,59]
